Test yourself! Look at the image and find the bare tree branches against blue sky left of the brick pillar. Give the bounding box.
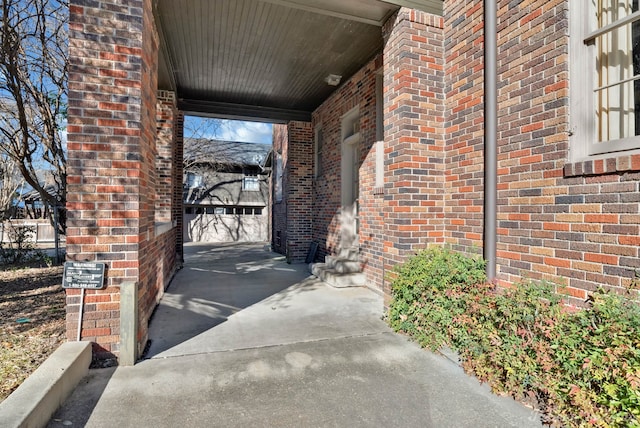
[0,0,69,232]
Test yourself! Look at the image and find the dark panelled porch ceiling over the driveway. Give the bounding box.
[155,0,443,122]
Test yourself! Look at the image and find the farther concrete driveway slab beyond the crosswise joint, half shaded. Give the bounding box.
[145,243,387,359]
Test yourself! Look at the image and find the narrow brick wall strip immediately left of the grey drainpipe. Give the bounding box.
[444,1,484,253]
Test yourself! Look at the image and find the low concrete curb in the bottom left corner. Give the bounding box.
[0,342,91,428]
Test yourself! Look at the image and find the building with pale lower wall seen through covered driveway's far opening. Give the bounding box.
[183,139,271,242]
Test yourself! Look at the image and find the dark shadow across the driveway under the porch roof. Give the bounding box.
[143,244,314,359]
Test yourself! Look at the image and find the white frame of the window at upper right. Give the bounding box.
[569,0,640,162]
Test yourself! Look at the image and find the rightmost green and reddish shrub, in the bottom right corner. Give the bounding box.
[544,289,640,427]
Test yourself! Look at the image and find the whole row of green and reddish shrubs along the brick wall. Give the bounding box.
[389,248,640,427]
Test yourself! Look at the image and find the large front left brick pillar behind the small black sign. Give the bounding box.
[67,0,158,357]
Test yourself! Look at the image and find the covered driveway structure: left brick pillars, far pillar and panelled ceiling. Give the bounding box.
[67,0,442,364]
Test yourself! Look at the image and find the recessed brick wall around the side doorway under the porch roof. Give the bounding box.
[313,55,384,287]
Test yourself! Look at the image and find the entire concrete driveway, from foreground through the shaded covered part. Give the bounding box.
[49,245,541,428]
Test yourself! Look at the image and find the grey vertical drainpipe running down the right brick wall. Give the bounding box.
[484,0,498,281]
